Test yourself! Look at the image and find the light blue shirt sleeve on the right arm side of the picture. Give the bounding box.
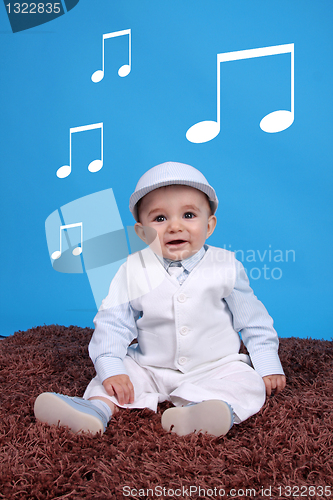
[224,261,284,377]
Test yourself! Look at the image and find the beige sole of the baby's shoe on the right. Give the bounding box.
[161,399,232,437]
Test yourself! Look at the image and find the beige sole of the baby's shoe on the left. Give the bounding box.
[34,392,104,434]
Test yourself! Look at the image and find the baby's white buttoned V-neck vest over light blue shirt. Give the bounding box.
[127,246,240,373]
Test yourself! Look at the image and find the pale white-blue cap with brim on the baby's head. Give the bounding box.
[129,161,218,221]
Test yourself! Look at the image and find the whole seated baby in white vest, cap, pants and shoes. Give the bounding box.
[35,162,286,436]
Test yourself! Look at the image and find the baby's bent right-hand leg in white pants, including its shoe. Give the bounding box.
[158,360,265,435]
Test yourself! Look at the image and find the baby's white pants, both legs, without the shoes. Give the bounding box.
[83,354,266,423]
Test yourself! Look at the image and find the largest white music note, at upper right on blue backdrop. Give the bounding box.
[186,43,294,144]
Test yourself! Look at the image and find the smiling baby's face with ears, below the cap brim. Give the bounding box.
[135,185,216,260]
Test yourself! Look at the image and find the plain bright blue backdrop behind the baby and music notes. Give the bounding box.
[0,0,333,339]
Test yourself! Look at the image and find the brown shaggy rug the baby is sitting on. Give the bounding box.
[0,325,333,500]
